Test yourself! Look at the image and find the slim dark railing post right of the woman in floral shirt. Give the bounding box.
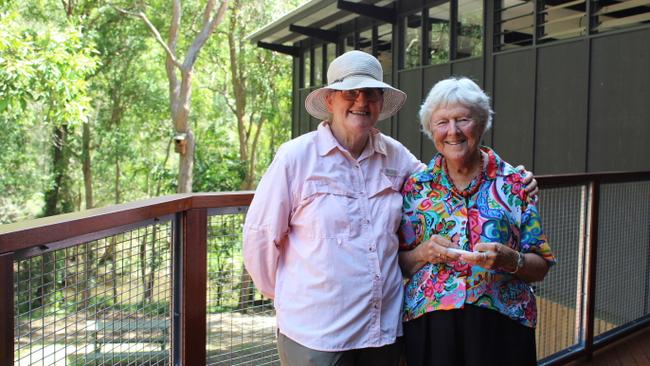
[585,180,600,360]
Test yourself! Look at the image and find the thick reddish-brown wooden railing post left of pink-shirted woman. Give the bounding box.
[175,208,208,366]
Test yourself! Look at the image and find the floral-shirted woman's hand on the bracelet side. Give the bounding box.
[460,243,519,272]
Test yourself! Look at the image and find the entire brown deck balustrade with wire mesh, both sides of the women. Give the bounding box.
[0,172,650,365]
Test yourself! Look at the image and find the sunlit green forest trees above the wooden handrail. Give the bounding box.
[0,0,301,223]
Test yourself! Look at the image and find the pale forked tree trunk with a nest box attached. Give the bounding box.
[120,0,228,193]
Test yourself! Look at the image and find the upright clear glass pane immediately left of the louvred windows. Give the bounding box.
[456,0,483,58]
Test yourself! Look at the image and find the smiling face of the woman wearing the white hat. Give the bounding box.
[326,89,384,136]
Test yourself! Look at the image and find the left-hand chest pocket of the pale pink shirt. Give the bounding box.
[291,178,356,241]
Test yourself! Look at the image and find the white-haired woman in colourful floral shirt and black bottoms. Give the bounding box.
[399,78,555,366]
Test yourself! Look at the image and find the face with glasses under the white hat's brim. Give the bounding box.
[326,91,384,136]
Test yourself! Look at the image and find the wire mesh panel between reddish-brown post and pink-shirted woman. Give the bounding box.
[207,209,279,365]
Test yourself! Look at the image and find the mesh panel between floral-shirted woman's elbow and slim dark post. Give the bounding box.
[535,186,588,359]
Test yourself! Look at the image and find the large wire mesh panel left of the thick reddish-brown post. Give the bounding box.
[14,222,172,366]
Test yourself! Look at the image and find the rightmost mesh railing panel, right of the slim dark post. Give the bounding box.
[594,181,650,336]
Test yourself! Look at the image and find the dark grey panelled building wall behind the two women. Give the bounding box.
[292,1,650,174]
